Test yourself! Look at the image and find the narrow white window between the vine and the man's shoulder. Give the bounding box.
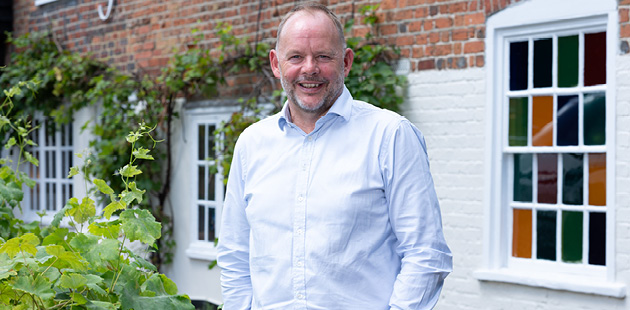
[184,107,233,260]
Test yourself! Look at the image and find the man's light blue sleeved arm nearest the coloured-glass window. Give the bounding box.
[383,120,453,310]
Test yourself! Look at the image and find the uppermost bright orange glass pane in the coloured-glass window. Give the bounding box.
[532,96,553,146]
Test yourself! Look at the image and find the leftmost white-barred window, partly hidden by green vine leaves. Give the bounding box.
[22,118,74,222]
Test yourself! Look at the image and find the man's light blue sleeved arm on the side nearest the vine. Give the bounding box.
[217,143,252,310]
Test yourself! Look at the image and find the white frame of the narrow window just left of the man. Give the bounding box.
[182,106,238,261]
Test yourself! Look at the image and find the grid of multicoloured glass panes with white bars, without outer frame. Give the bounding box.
[504,31,607,266]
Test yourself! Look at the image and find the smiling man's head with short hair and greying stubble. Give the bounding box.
[270,12,353,114]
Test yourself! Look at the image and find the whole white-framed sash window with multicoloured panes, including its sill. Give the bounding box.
[475,0,625,297]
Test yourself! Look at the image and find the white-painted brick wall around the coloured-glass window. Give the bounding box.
[403,56,630,310]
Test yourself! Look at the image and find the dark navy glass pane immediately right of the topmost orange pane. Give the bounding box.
[556,96,579,146]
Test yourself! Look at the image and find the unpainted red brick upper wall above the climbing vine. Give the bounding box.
[14,0,532,77]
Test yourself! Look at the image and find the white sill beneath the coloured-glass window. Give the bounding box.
[473,269,626,298]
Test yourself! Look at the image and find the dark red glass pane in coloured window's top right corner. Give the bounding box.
[584,32,606,86]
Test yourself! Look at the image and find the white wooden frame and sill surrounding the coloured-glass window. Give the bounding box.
[474,0,626,298]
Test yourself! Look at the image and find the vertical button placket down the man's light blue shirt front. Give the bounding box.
[292,135,314,309]
